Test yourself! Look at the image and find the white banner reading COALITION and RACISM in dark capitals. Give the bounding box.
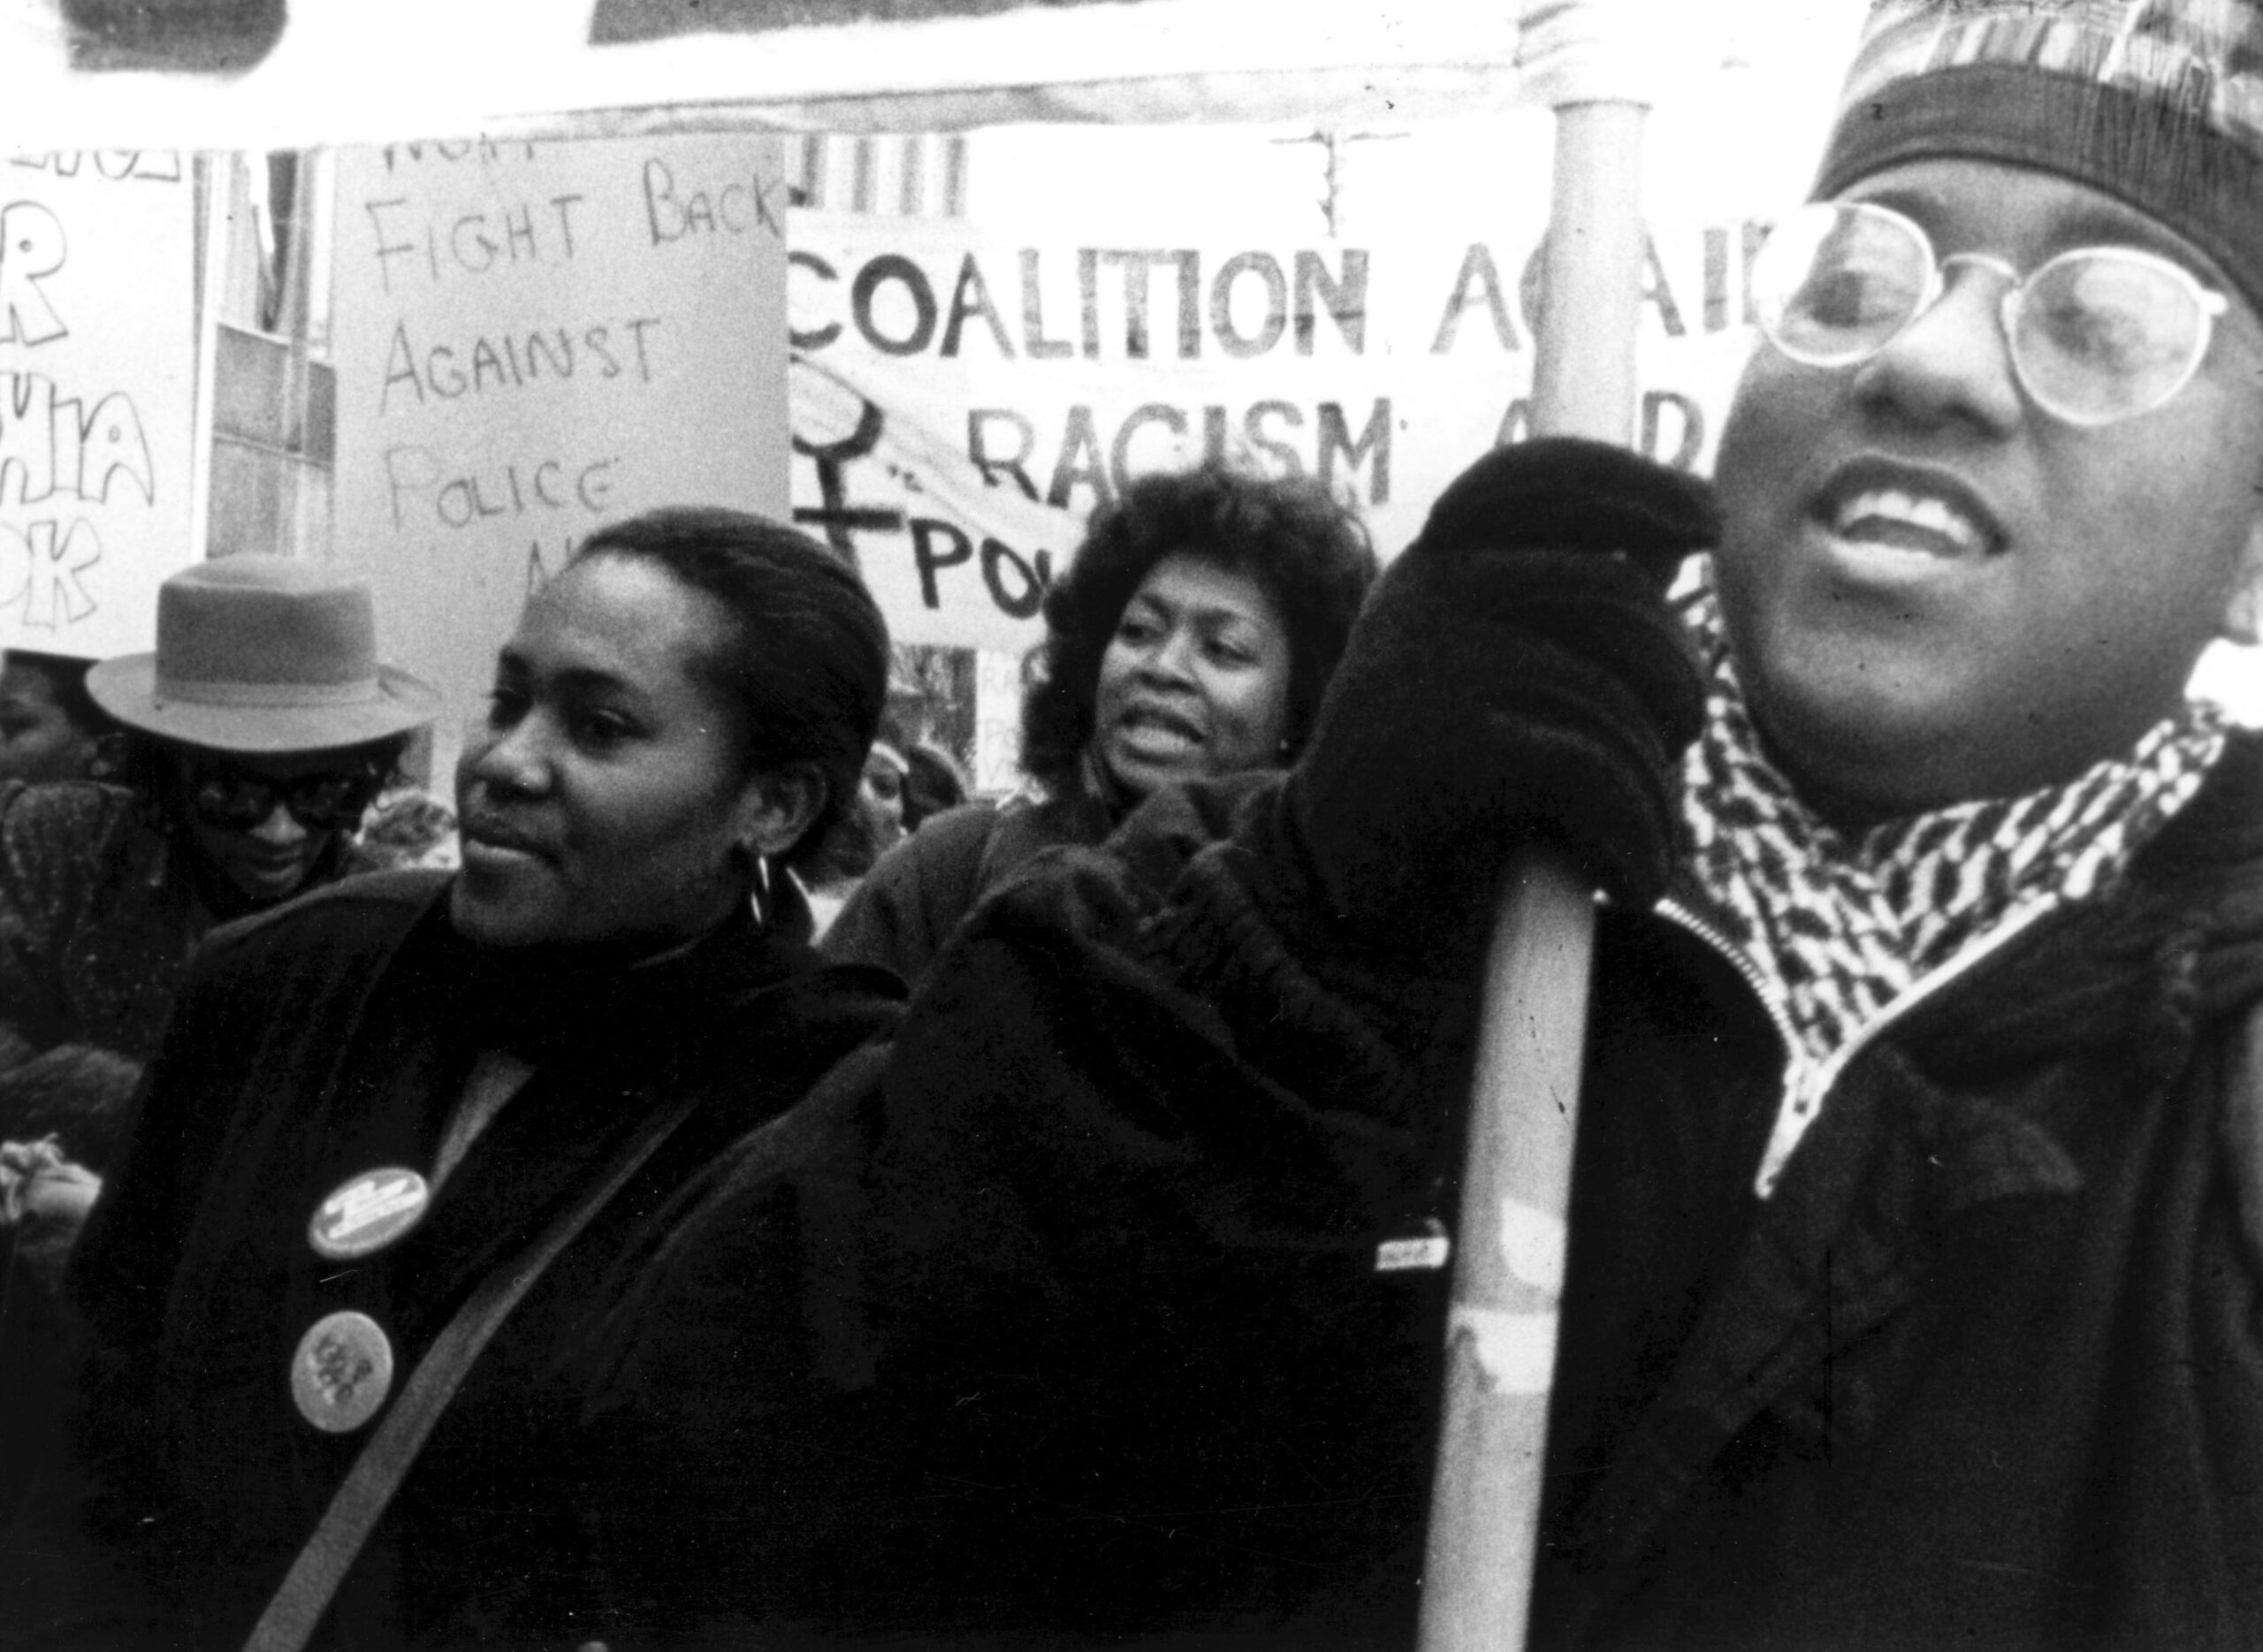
[788,213,1761,650]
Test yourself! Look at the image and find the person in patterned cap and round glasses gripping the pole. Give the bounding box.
[637,0,2263,1652]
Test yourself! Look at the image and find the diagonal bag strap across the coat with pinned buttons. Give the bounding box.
[244,1095,699,1652]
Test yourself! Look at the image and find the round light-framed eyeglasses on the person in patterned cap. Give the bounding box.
[1751,202,2229,425]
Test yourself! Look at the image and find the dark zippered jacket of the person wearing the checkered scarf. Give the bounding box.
[756,735,2263,1652]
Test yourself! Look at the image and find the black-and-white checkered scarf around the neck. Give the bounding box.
[1681,586,2227,1197]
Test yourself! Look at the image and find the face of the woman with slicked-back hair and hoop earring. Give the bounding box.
[453,554,787,946]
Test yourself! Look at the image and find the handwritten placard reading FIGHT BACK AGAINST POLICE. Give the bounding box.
[332,136,788,740]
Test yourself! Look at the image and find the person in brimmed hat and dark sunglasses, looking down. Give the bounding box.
[0,557,439,1172]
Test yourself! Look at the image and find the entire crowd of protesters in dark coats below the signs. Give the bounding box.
[0,0,2263,1652]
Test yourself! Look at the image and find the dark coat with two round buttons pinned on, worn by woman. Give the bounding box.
[0,873,892,1648]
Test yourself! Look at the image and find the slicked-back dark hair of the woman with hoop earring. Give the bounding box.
[575,507,888,864]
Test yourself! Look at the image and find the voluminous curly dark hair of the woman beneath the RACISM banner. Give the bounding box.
[1021,460,1375,795]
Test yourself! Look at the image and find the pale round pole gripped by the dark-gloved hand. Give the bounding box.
[1419,64,1645,1652]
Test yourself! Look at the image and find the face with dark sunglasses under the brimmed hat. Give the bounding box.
[174,751,376,905]
